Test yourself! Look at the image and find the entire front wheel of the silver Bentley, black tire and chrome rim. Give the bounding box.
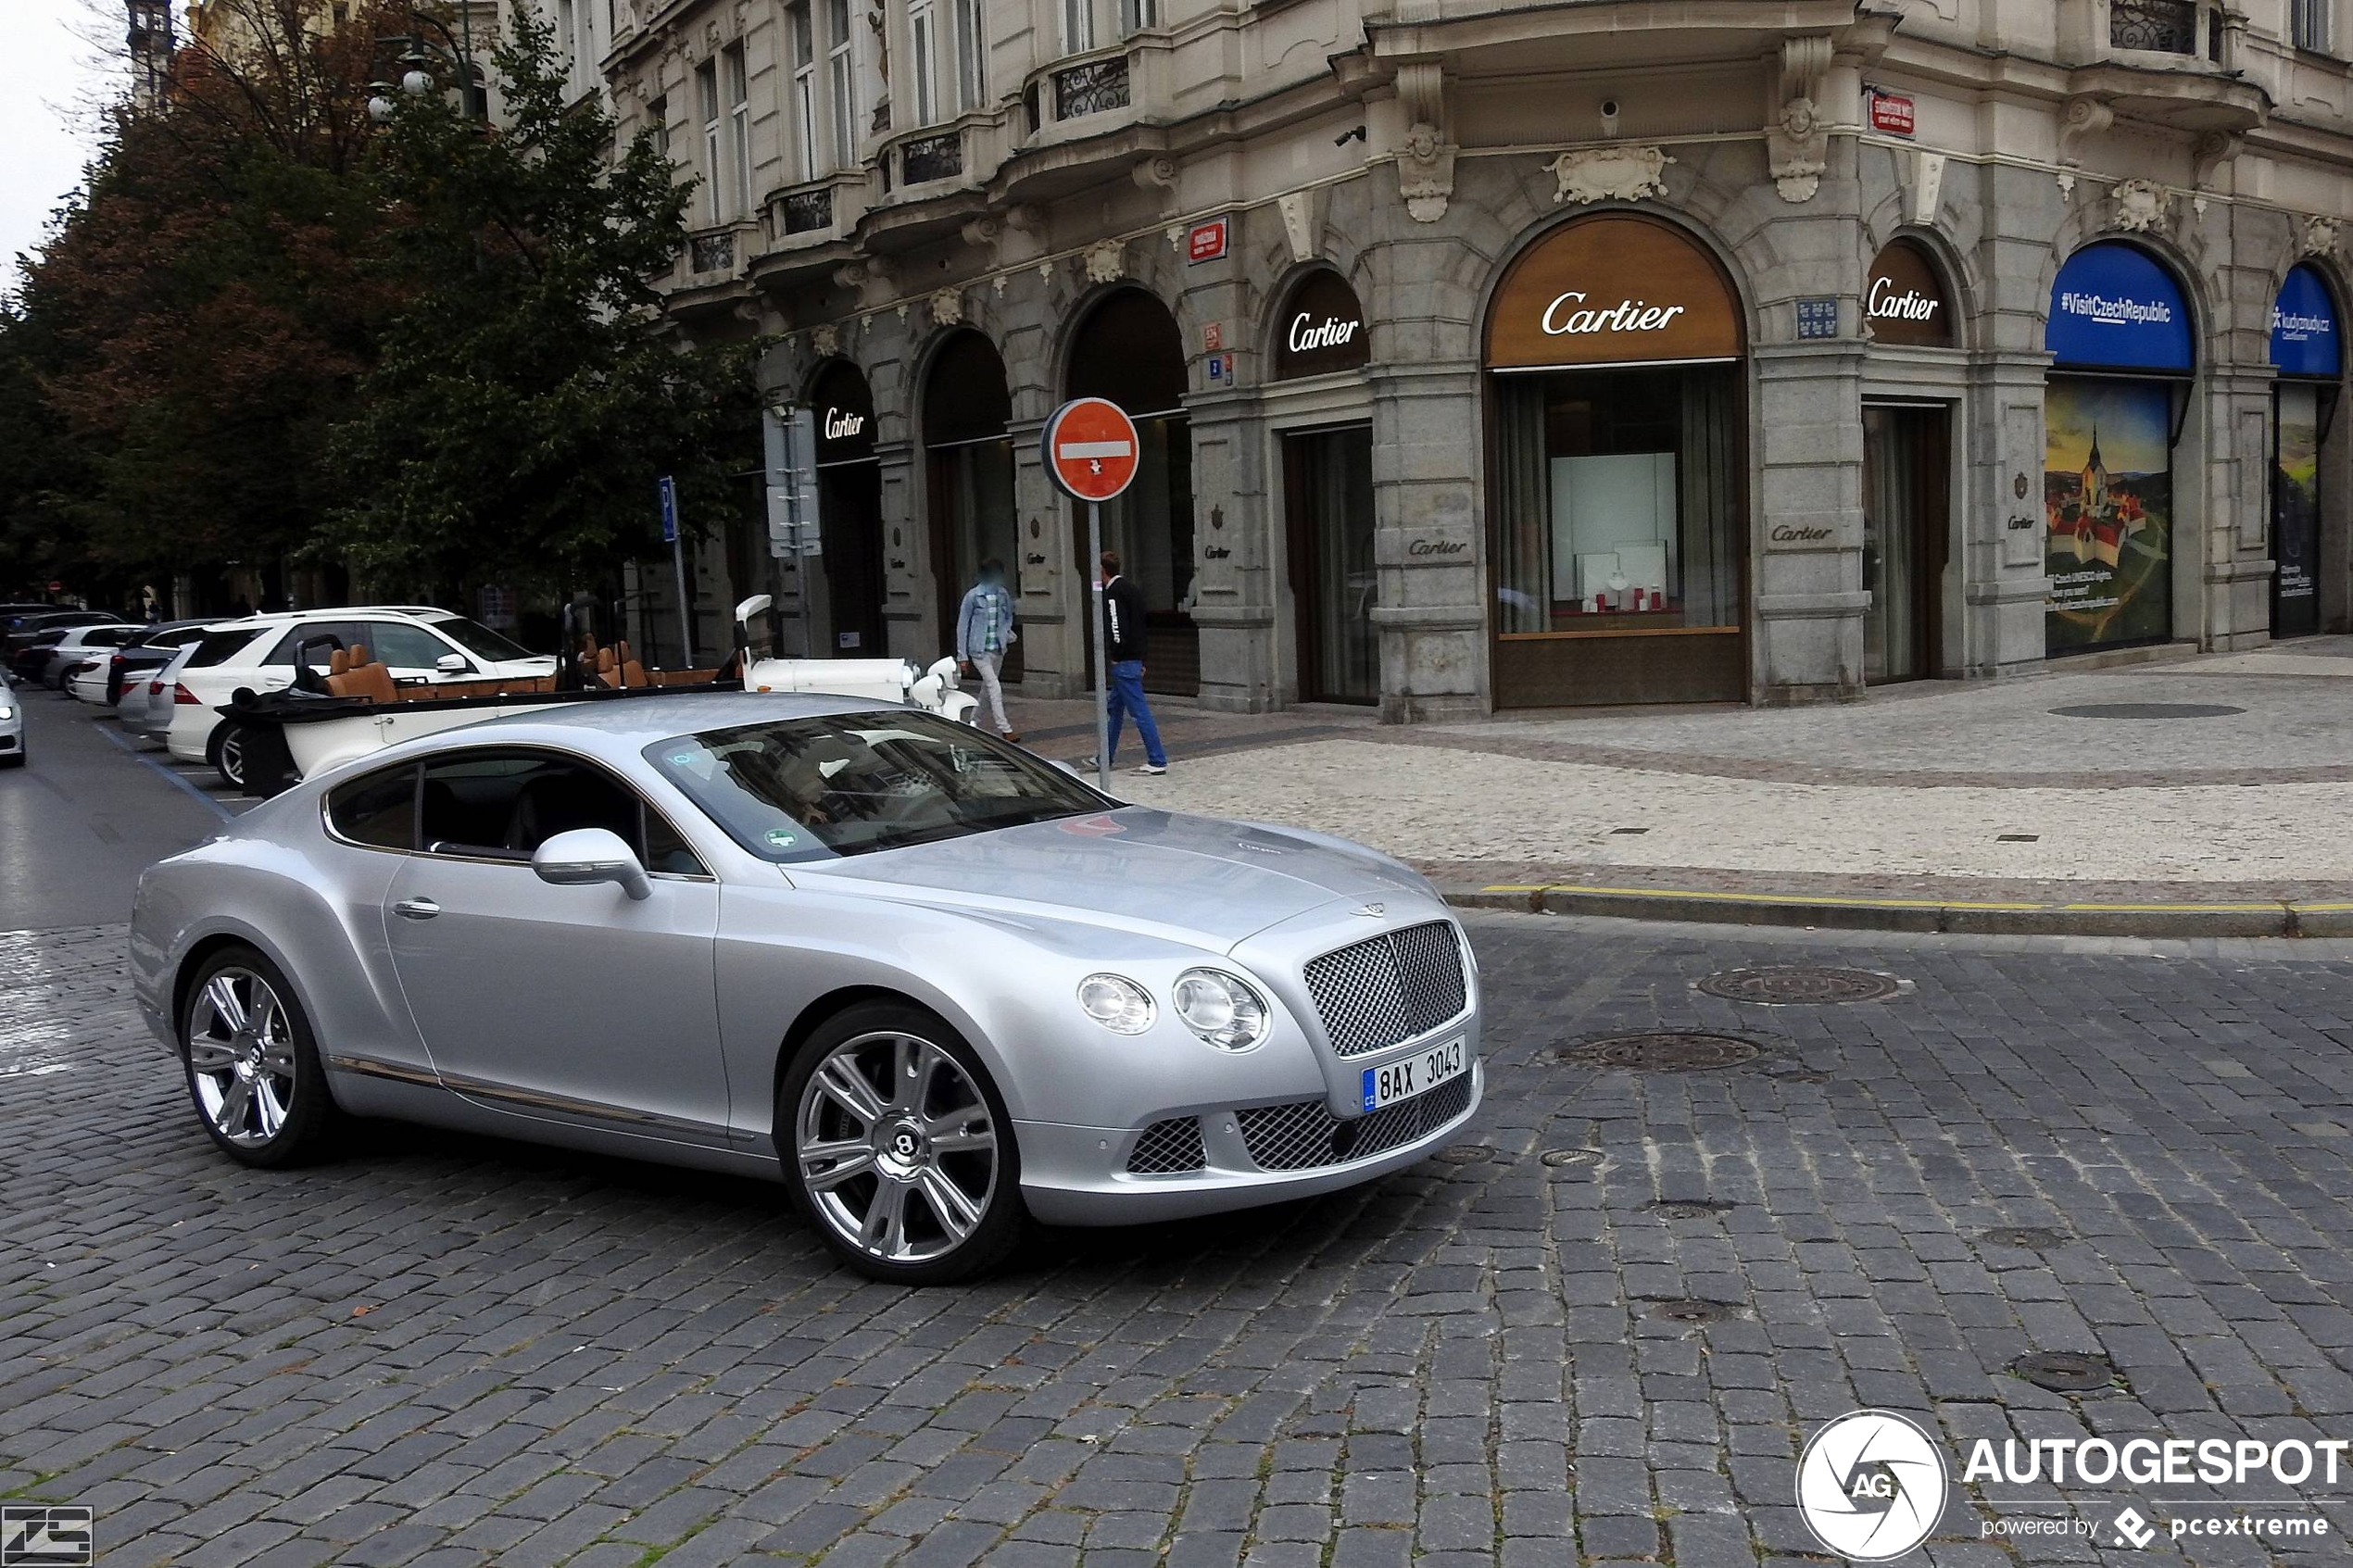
[779,1004,1021,1284]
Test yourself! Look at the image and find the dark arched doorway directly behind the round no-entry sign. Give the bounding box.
[1063,289,1200,696]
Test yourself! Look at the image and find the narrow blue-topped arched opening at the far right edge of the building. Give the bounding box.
[2271,263,2346,637]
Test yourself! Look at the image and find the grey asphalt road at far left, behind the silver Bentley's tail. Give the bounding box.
[0,686,252,931]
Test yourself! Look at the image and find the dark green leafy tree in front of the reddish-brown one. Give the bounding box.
[332,5,753,585]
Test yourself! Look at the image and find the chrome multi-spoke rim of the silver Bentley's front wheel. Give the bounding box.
[793,1032,1000,1262]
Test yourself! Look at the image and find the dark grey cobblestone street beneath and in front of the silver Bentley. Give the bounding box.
[0,914,2353,1568]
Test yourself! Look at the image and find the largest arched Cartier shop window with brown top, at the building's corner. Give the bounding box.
[1487,211,1748,708]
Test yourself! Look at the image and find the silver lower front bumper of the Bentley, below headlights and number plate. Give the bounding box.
[1014,1062,1487,1224]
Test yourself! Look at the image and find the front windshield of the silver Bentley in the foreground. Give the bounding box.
[645,710,1111,860]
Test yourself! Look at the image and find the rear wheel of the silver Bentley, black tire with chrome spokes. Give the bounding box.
[179,945,339,1169]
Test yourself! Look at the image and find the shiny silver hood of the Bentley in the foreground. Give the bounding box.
[788,807,1430,947]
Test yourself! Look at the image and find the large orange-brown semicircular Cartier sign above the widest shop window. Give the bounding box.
[1487,211,1743,370]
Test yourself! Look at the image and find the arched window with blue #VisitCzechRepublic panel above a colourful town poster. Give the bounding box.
[2043,240,2197,654]
